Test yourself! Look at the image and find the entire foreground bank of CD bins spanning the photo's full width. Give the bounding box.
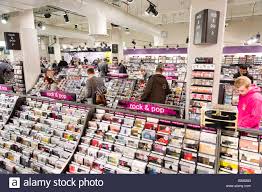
[0,91,262,174]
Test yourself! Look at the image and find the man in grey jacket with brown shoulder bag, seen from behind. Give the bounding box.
[85,68,107,104]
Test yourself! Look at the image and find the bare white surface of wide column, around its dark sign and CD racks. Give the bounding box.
[186,0,227,118]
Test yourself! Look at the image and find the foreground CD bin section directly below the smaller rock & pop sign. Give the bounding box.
[0,93,89,174]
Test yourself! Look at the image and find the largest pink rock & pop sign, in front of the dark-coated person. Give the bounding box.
[118,101,179,117]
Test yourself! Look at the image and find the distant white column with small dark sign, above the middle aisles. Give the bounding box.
[111,27,124,61]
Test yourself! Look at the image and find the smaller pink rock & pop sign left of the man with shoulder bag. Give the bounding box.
[40,91,76,101]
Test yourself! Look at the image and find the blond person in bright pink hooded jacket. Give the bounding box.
[235,76,262,129]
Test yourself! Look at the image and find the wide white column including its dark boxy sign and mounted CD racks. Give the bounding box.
[186,0,227,119]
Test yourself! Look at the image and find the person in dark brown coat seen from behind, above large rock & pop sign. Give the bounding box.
[141,67,171,104]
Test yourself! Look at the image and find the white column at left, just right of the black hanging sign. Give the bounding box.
[17,10,41,91]
